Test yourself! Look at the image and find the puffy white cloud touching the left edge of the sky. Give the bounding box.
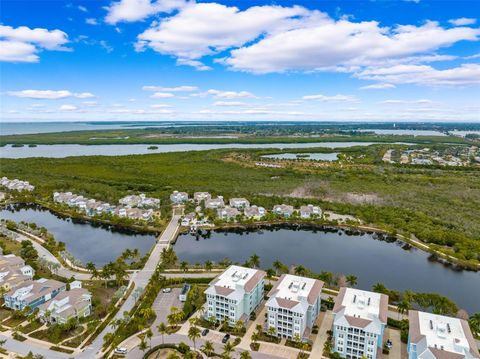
[0,25,69,62]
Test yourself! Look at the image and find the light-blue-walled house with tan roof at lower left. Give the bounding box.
[3,278,66,310]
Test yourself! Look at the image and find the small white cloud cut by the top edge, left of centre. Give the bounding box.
[105,0,186,25]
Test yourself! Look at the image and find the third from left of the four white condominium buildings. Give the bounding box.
[333,287,388,359]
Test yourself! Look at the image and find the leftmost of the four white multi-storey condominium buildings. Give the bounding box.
[205,265,266,325]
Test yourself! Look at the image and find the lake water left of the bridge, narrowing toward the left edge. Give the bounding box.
[0,207,155,266]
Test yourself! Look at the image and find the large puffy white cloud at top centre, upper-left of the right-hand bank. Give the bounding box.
[137,3,316,70]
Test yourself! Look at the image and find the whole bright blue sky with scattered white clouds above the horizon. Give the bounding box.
[0,0,480,122]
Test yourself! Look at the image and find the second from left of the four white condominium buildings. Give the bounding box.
[266,274,323,339]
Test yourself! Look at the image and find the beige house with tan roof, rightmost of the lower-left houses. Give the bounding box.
[38,287,92,324]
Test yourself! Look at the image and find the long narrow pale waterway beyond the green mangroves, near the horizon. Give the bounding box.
[0,142,386,158]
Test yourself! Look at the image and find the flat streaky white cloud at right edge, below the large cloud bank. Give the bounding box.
[356,64,480,86]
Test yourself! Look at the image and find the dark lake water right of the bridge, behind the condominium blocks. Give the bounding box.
[174,229,480,313]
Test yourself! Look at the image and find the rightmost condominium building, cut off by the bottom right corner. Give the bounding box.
[408,310,480,359]
